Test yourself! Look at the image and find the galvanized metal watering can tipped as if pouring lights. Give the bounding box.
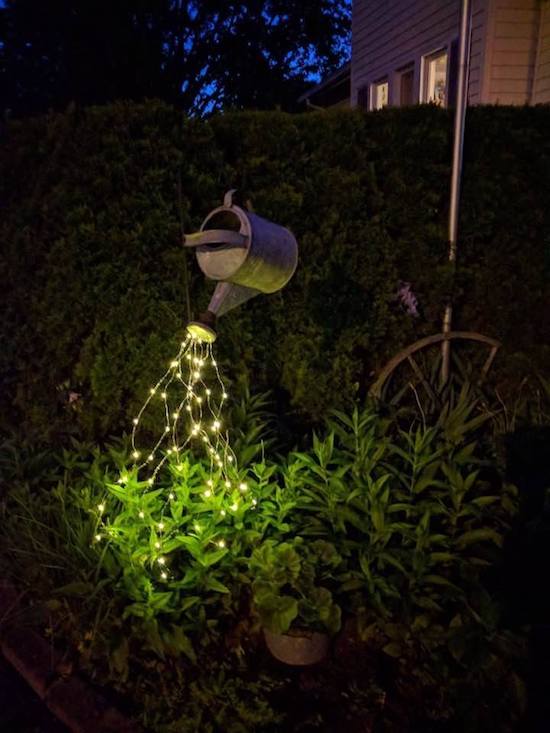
[183,189,298,342]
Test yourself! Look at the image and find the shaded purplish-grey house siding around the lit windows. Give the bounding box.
[351,0,490,105]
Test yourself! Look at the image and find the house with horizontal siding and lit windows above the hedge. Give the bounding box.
[303,0,550,110]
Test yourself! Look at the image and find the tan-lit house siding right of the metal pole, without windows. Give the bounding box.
[483,0,540,104]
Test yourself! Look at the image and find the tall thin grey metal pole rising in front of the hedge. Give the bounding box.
[441,0,472,384]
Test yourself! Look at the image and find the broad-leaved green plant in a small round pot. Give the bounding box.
[250,537,342,665]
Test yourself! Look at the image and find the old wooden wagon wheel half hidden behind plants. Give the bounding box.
[369,331,501,405]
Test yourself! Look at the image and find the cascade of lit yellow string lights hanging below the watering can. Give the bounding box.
[94,335,248,580]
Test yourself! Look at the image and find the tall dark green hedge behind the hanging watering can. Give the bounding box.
[0,101,550,440]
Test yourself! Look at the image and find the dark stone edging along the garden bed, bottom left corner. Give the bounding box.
[0,580,142,733]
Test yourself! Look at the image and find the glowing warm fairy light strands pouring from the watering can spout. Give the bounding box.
[93,336,264,581]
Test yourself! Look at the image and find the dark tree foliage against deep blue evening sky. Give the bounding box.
[0,0,351,114]
